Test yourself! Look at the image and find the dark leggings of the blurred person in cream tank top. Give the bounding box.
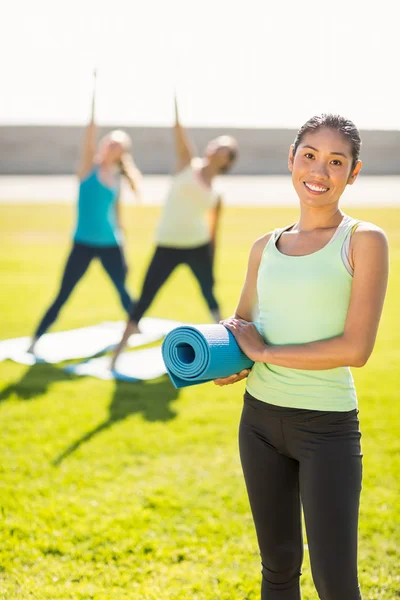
[130,244,218,323]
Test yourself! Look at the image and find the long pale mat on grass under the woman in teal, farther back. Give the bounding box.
[0,317,182,365]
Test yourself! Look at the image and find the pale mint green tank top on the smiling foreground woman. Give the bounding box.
[246,217,358,411]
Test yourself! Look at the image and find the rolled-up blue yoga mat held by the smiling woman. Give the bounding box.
[162,325,254,388]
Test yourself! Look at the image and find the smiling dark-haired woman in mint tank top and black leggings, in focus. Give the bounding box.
[216,115,388,600]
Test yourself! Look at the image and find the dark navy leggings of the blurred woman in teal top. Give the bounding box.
[35,242,133,337]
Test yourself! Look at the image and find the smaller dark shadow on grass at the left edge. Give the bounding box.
[0,363,76,402]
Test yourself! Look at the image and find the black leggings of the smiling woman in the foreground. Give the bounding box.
[239,392,362,600]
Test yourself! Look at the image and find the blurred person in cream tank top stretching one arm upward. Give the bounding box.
[111,97,238,368]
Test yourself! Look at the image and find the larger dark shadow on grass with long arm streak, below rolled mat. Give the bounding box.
[53,377,179,466]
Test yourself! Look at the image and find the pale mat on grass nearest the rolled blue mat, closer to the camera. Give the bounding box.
[64,346,167,381]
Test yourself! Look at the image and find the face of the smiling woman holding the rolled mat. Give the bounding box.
[289,127,362,207]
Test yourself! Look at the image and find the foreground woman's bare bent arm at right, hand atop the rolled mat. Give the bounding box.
[226,224,389,370]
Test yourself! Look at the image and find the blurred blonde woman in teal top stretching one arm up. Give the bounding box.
[29,71,140,352]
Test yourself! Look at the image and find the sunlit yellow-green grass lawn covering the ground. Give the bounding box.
[0,205,400,600]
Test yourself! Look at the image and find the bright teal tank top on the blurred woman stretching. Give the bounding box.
[74,167,121,246]
